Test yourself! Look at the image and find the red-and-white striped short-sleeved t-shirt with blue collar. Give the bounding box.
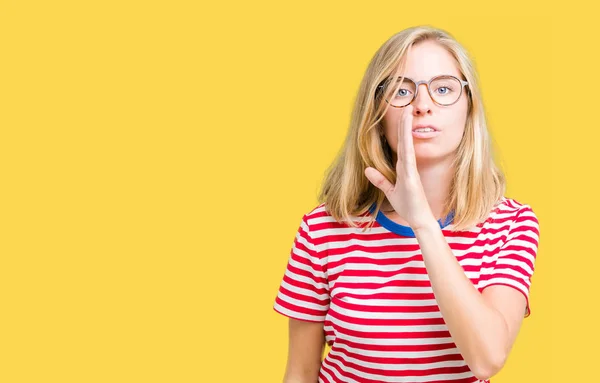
[273,197,539,383]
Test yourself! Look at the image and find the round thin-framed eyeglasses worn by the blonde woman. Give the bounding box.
[377,75,469,108]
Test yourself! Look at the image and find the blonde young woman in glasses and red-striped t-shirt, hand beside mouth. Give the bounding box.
[274,26,539,383]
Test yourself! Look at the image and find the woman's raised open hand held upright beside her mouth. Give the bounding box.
[365,105,435,231]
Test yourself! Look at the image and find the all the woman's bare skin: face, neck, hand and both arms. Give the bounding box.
[284,41,526,383]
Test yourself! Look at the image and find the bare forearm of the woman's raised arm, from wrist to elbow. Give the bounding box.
[415,220,508,379]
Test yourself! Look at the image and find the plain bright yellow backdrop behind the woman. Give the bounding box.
[0,1,600,383]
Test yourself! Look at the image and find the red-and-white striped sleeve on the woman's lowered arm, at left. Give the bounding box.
[273,215,330,322]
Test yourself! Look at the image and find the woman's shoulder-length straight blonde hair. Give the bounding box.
[318,26,506,234]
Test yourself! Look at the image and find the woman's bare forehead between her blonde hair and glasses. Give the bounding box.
[401,41,461,81]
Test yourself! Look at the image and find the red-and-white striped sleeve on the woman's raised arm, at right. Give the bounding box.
[479,205,540,317]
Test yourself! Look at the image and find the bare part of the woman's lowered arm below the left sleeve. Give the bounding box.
[283,318,325,383]
